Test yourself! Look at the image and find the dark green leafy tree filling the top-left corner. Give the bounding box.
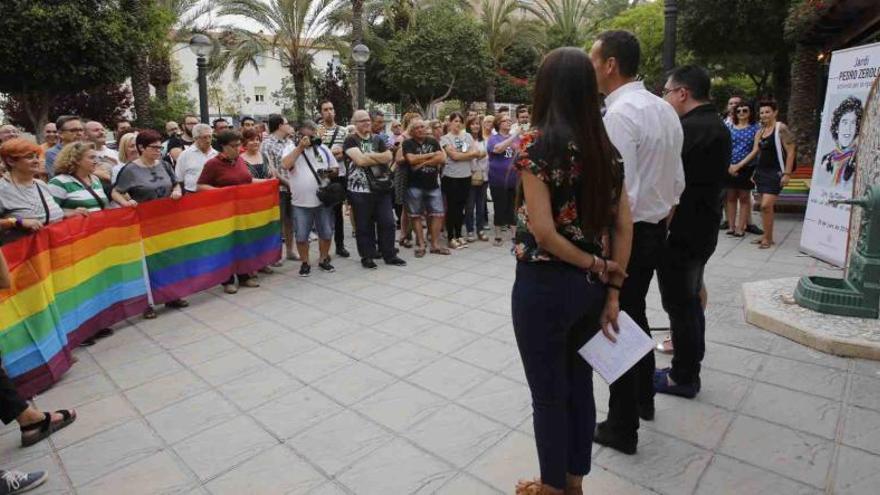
[0,0,142,138]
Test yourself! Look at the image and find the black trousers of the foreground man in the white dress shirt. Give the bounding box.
[608,222,666,435]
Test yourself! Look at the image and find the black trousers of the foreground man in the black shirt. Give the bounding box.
[657,252,708,385]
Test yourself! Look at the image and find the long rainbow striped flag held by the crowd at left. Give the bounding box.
[0,181,280,397]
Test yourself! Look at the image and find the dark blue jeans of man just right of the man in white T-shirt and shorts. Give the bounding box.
[348,191,394,260]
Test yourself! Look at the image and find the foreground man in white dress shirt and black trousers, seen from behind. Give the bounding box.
[590,31,685,454]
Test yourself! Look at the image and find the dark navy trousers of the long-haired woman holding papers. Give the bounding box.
[512,262,605,489]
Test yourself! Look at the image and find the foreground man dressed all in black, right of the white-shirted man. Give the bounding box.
[654,66,731,398]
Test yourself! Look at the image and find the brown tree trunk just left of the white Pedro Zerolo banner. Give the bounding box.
[788,44,820,164]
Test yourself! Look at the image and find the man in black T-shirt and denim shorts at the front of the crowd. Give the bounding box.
[402,119,449,258]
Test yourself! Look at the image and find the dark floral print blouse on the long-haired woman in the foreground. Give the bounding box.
[514,129,623,262]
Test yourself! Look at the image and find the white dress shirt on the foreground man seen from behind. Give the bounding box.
[604,81,684,223]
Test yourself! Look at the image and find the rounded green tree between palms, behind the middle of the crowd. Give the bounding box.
[383,4,491,115]
